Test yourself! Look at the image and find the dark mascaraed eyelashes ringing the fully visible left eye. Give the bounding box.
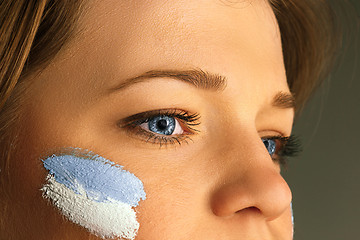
[118,109,200,147]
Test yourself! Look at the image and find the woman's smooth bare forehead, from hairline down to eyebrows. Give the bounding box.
[31,0,288,115]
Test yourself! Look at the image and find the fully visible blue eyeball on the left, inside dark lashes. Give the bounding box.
[139,115,184,135]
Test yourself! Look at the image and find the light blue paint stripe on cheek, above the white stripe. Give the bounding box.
[43,149,146,207]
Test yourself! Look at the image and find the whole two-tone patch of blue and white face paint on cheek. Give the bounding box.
[41,149,146,239]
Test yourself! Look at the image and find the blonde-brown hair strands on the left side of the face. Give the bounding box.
[0,0,82,170]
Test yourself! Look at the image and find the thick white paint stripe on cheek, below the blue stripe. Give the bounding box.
[41,174,139,240]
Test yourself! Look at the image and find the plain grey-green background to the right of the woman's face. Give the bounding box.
[283,0,360,240]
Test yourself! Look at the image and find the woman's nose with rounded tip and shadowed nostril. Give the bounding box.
[211,137,292,221]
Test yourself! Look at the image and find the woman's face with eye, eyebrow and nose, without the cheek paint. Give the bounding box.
[9,0,293,240]
